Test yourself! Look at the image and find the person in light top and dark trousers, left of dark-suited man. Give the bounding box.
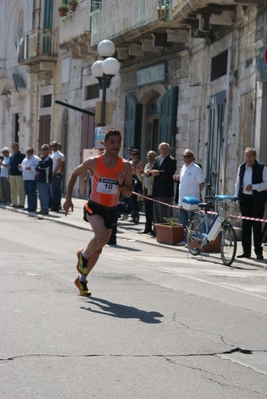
[137,151,157,234]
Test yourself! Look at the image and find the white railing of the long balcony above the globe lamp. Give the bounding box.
[91,0,172,46]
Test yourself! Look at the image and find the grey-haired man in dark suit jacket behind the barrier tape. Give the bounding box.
[148,142,176,231]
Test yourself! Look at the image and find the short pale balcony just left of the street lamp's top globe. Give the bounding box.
[59,0,97,59]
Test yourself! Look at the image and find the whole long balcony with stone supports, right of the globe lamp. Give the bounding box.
[91,0,191,60]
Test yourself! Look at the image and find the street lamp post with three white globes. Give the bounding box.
[92,40,120,126]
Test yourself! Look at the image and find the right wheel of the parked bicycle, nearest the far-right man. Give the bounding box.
[221,223,237,266]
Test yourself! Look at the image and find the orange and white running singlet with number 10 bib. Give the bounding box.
[90,155,123,208]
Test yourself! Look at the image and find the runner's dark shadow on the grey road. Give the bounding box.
[81,298,163,324]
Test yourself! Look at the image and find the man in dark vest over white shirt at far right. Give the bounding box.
[235,148,267,259]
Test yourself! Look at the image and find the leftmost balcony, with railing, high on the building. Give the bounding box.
[18,29,58,72]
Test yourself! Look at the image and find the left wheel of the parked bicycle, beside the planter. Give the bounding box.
[186,213,203,256]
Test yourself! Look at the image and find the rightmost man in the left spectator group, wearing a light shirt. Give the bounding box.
[50,141,63,212]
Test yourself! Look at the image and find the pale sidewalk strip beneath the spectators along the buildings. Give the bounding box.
[0,198,267,269]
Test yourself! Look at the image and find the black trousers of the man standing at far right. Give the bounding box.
[240,194,265,255]
